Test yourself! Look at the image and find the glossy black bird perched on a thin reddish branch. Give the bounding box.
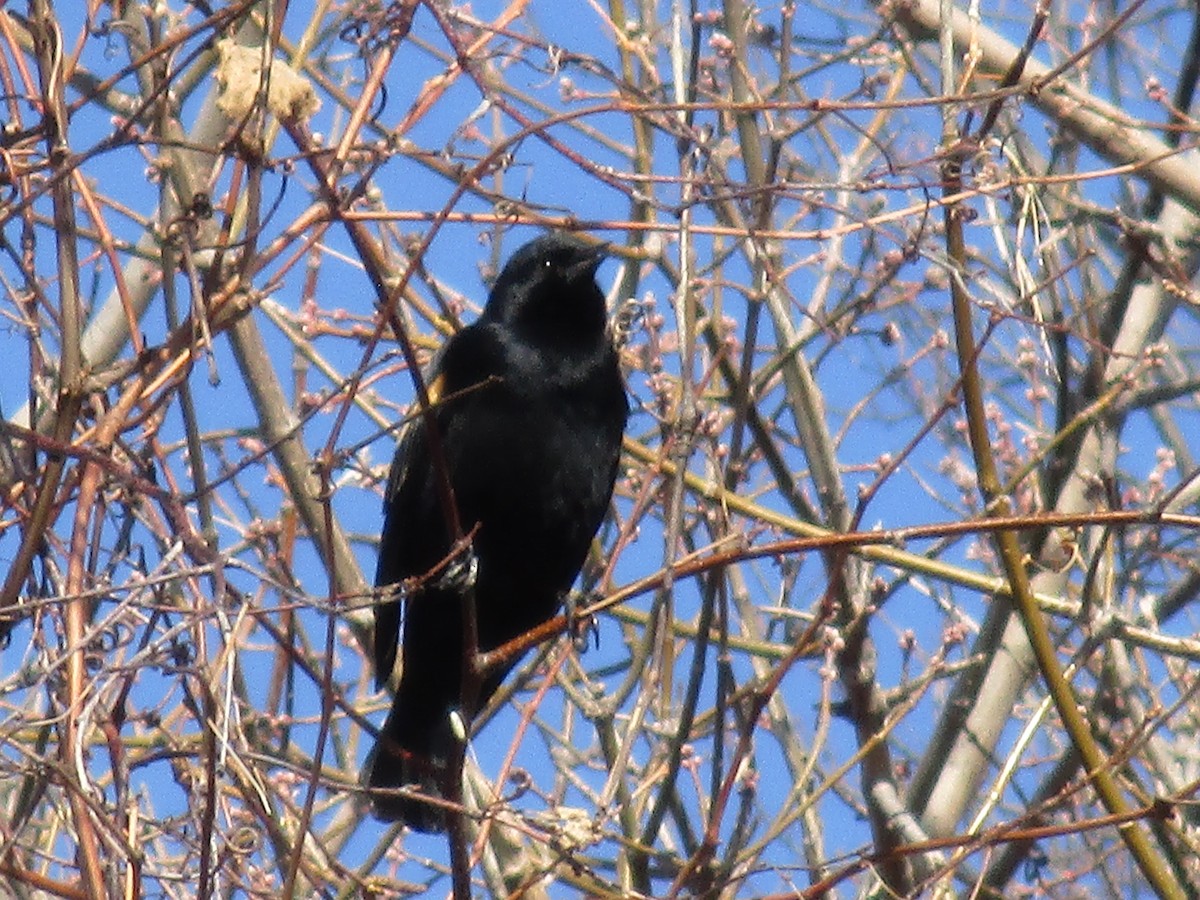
[367,233,629,832]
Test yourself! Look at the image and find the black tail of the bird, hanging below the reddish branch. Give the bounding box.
[365,679,454,834]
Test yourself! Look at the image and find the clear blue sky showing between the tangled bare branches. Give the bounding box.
[0,1,1198,896]
